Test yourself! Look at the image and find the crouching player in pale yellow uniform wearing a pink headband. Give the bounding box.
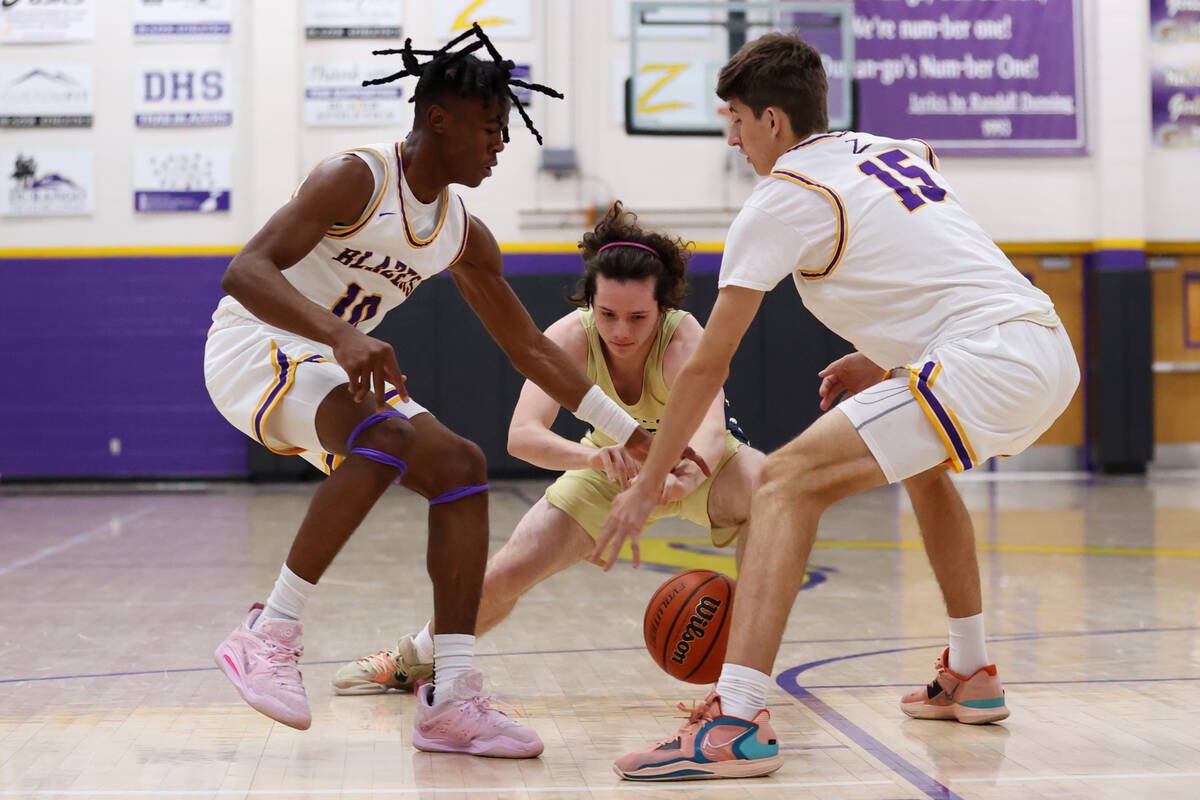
[334,203,763,694]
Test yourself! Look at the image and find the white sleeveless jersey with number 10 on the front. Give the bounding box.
[214,142,469,332]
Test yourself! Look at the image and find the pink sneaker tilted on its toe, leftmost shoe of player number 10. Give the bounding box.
[214,603,312,730]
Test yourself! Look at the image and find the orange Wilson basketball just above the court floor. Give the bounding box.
[642,570,734,684]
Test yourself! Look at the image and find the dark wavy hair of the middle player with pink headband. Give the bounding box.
[566,200,691,311]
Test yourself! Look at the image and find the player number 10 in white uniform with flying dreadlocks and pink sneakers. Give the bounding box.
[204,26,700,758]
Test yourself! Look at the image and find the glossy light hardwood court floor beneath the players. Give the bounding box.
[0,474,1200,800]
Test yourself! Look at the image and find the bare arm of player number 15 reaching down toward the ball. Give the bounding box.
[592,285,763,570]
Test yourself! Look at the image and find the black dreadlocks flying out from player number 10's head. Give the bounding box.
[362,23,563,144]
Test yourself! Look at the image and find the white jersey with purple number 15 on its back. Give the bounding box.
[719,132,1058,367]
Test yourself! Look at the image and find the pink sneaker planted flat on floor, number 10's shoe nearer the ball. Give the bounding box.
[413,672,542,758]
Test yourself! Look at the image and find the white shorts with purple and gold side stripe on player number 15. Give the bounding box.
[838,320,1079,483]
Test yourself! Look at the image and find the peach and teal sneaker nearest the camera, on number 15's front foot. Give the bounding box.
[613,692,784,781]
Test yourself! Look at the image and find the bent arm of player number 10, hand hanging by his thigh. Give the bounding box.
[221,155,408,407]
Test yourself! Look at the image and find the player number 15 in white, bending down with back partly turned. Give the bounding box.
[593,34,1079,780]
